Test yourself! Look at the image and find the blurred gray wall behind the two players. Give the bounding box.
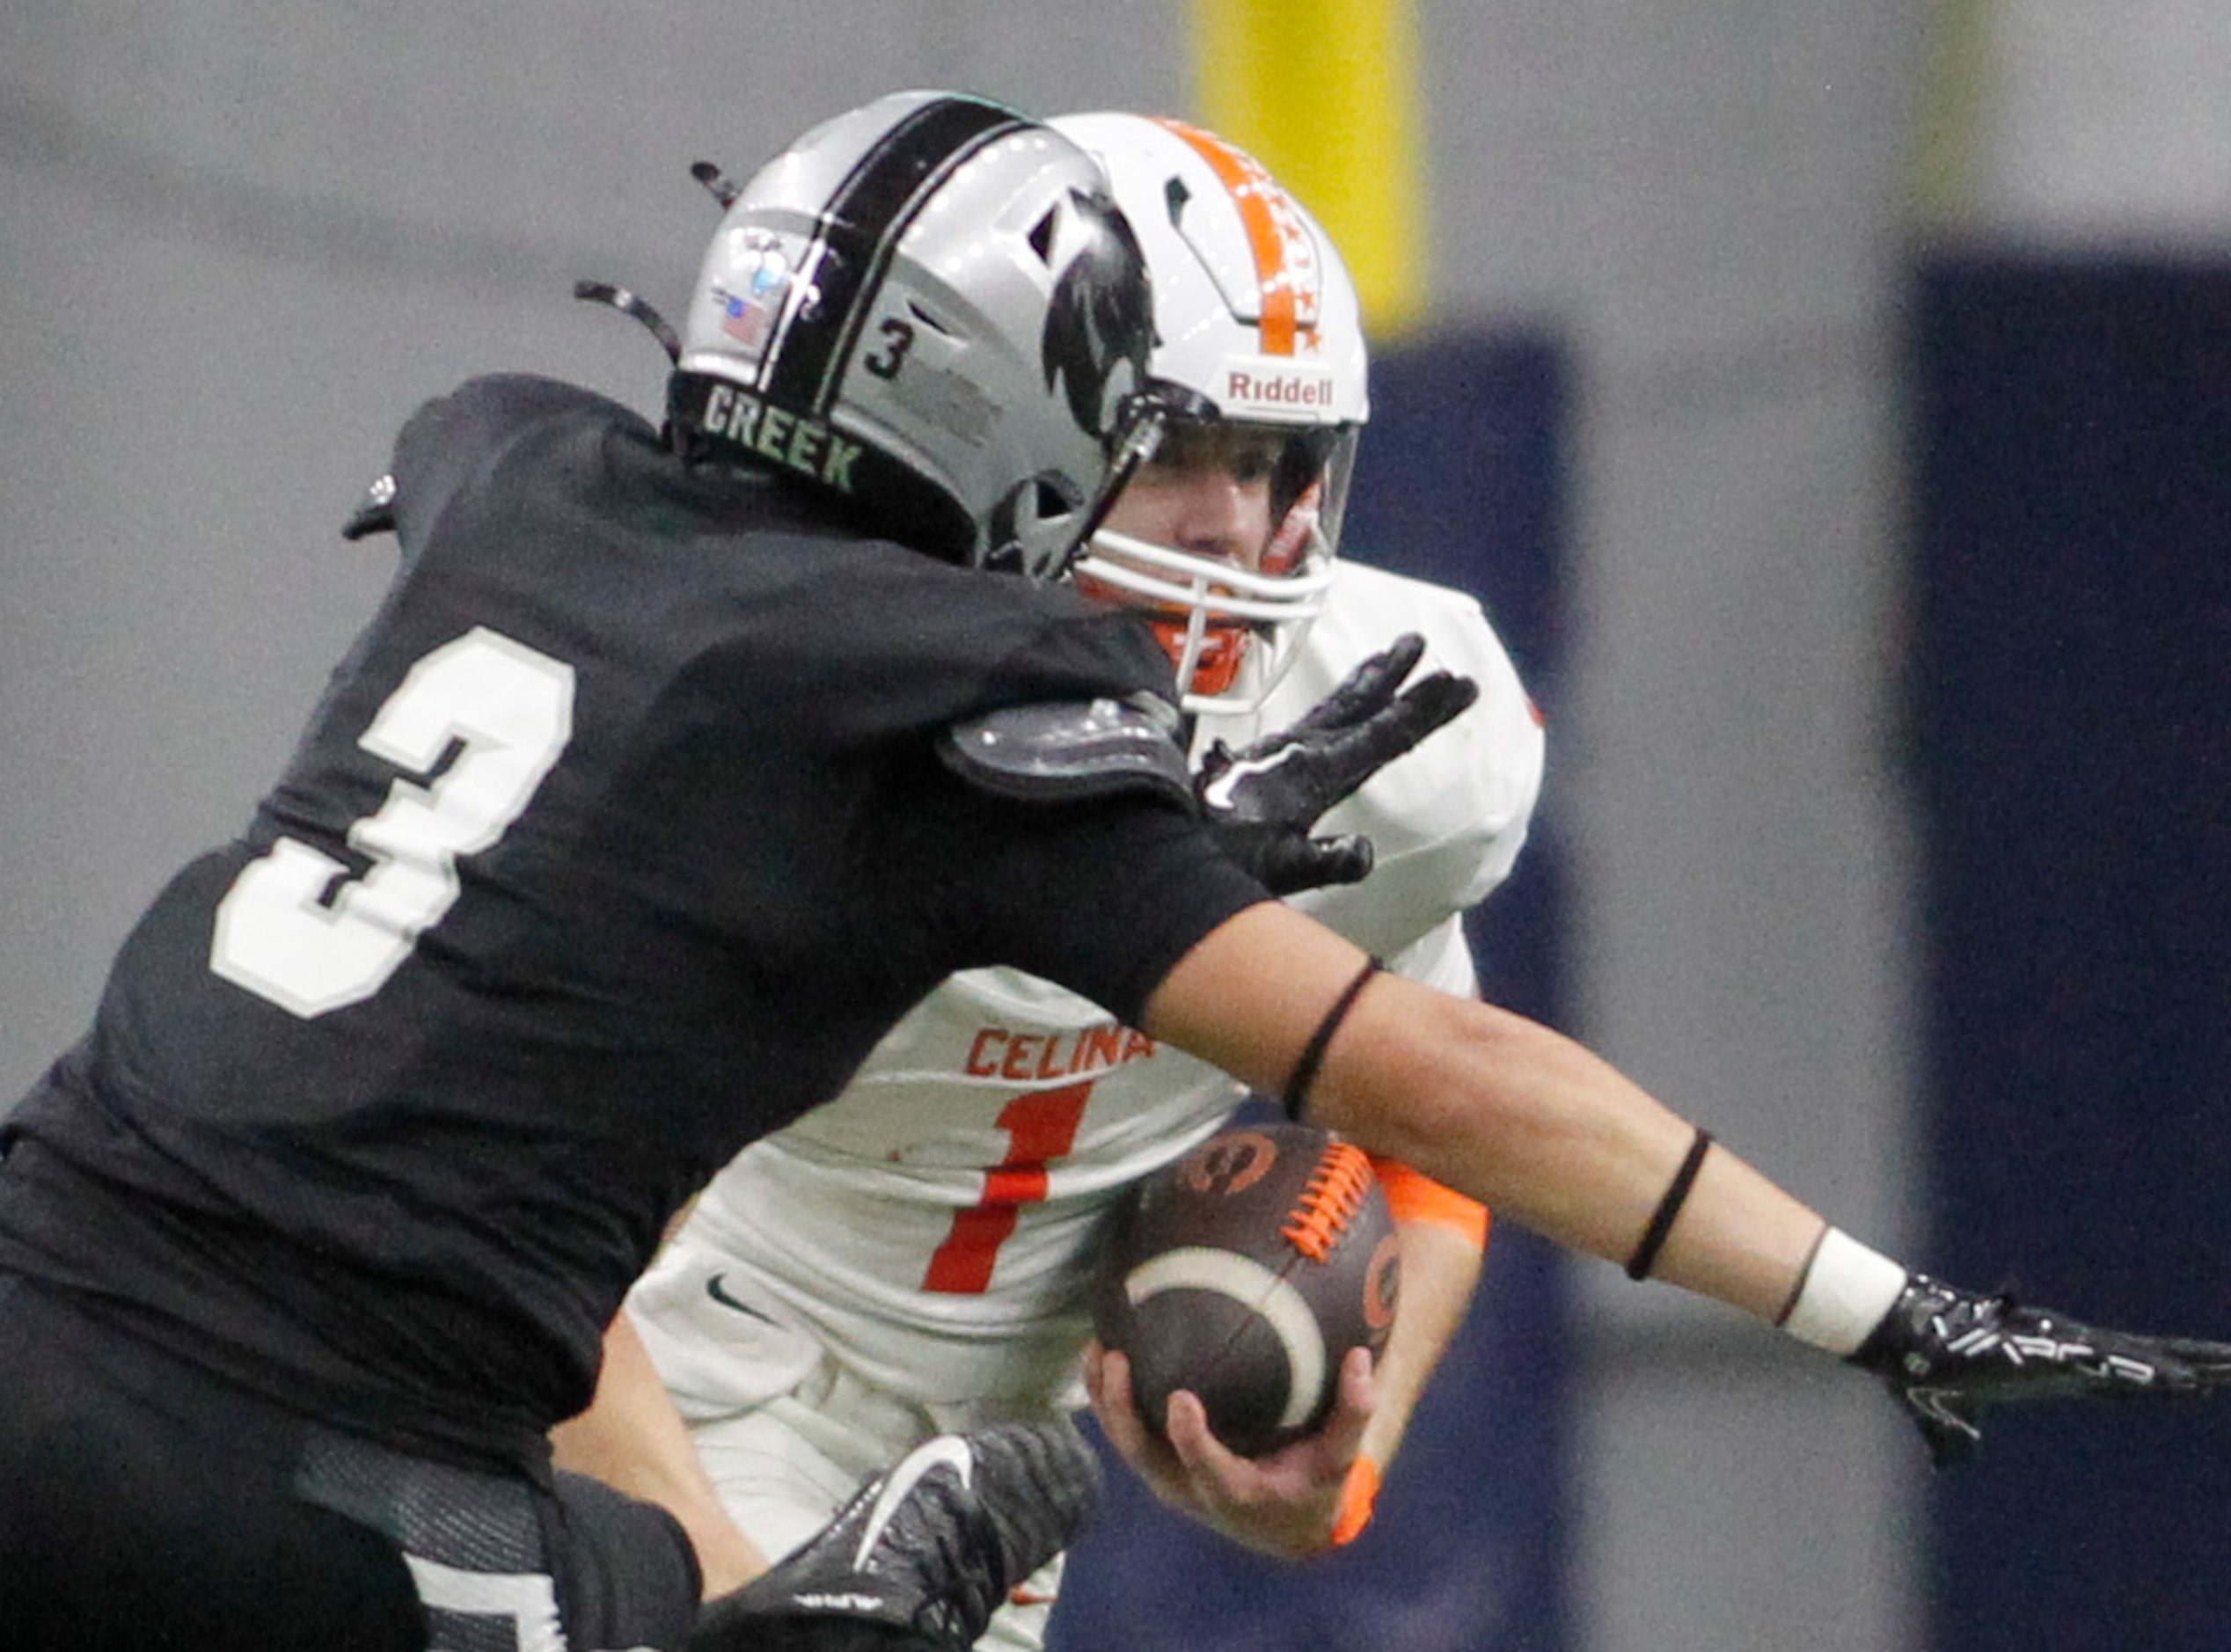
[0,0,2231,1652]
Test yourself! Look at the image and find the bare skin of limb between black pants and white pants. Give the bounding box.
[551,1313,767,1598]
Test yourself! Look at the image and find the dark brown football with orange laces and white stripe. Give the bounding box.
[1094,1123,1401,1458]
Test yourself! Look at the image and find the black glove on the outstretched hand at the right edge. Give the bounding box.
[1852,1273,2231,1469]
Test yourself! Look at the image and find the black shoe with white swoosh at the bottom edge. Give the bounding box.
[687,1420,1100,1652]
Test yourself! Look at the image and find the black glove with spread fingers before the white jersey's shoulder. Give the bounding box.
[1194,633,1479,894]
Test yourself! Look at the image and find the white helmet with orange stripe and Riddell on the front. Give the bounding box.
[1049,113,1370,716]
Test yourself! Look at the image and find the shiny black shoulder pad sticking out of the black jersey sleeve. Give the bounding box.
[937,696,1194,807]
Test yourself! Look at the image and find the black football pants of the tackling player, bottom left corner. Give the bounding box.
[0,1273,696,1652]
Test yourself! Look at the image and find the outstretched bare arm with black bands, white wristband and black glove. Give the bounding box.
[1140,903,2231,1465]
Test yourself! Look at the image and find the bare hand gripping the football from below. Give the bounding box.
[1084,1342,1377,1561]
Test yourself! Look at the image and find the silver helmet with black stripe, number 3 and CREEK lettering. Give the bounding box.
[667,91,1153,580]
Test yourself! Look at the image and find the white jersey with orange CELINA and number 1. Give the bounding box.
[629,564,1541,1427]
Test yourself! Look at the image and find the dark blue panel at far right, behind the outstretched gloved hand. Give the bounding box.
[1907,259,2231,1652]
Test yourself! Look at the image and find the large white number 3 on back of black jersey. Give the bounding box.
[209,626,574,1019]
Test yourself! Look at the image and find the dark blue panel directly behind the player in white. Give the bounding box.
[1053,337,1569,1652]
